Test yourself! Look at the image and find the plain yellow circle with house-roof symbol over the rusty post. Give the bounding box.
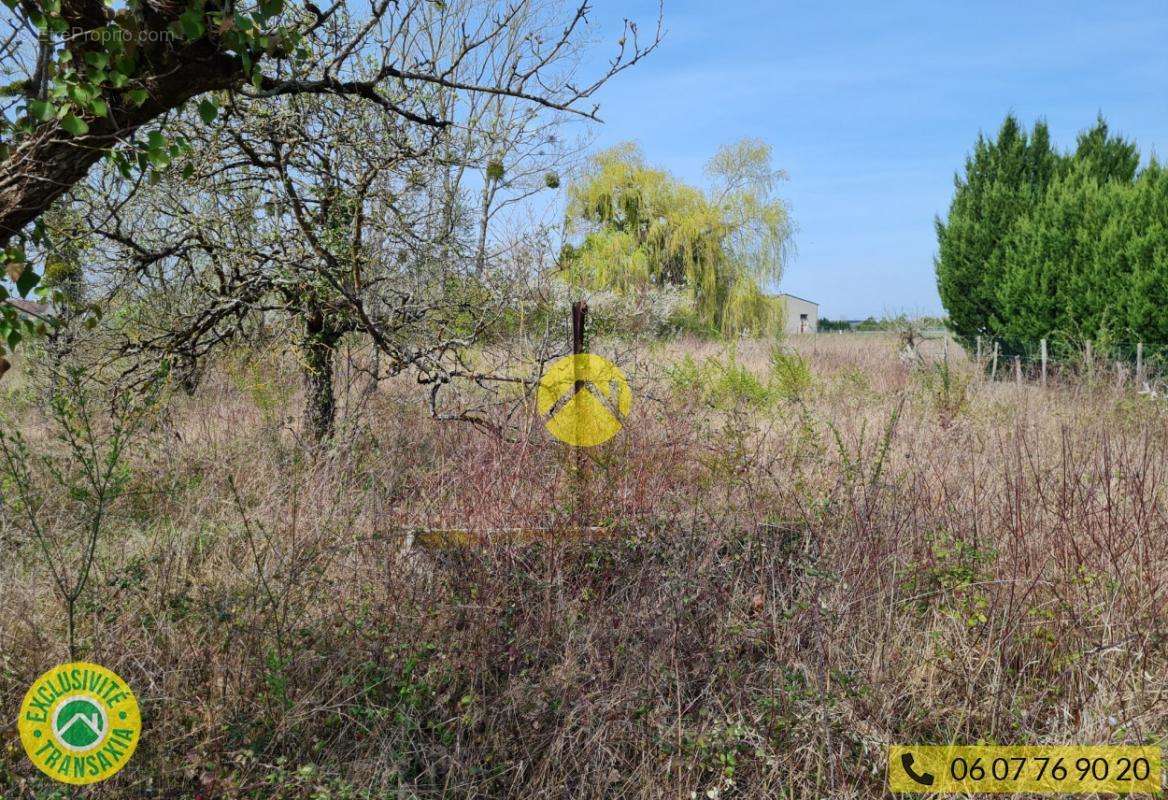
[535,353,633,447]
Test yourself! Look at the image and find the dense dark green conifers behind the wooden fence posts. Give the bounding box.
[936,116,1168,352]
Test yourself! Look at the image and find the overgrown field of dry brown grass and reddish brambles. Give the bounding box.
[0,335,1168,800]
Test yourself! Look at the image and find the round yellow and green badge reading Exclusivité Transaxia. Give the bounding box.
[16,661,142,785]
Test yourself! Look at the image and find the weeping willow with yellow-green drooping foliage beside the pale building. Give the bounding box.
[564,139,792,334]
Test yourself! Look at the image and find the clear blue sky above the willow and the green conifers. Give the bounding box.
[579,0,1168,318]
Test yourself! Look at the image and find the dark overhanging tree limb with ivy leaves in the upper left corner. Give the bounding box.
[0,0,660,359]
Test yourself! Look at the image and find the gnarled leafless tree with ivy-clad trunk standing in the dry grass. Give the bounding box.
[75,3,621,441]
